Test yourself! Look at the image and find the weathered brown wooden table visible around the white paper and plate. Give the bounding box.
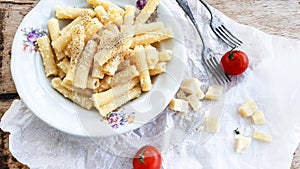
[0,0,300,169]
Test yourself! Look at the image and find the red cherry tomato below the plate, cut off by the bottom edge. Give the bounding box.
[132,145,162,169]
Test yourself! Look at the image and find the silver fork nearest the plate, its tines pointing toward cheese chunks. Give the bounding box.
[176,0,231,84]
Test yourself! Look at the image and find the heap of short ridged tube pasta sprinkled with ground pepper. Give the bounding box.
[37,0,173,116]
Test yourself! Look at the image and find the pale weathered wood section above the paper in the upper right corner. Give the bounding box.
[206,0,300,40]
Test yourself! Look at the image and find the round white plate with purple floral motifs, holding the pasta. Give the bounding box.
[11,0,186,137]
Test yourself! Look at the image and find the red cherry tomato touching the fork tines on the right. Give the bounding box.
[221,50,249,75]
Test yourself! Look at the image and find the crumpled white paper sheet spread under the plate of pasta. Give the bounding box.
[0,0,300,169]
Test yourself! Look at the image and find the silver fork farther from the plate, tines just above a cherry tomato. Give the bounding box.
[199,0,243,48]
